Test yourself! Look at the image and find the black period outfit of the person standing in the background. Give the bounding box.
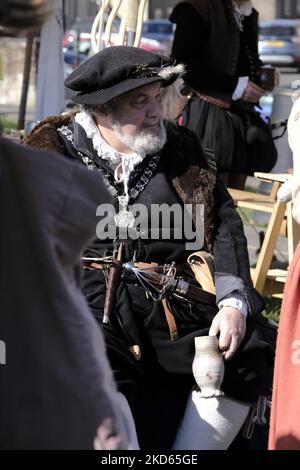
[170,0,277,175]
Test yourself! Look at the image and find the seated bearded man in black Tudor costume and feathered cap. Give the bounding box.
[27,46,272,450]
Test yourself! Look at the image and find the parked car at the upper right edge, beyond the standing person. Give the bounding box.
[259,19,300,71]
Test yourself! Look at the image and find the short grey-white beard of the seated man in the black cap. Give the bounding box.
[113,120,167,155]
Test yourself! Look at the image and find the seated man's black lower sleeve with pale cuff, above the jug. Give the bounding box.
[214,179,264,315]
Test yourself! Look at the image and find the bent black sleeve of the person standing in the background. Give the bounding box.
[171,3,238,94]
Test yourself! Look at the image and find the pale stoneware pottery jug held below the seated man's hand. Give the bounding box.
[192,336,224,398]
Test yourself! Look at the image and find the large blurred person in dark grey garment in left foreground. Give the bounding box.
[0,1,137,449]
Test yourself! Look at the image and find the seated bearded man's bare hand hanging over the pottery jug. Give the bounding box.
[209,307,246,360]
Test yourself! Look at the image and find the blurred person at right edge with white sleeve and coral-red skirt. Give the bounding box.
[269,98,300,450]
